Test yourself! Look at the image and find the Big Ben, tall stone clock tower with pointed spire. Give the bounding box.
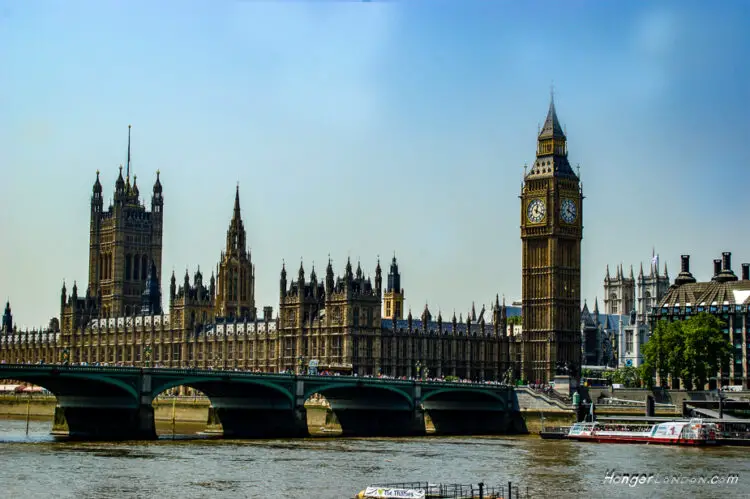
[520,95,583,383]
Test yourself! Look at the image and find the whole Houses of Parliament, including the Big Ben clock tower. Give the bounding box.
[0,101,583,382]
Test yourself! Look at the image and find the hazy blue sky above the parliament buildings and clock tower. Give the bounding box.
[0,0,750,326]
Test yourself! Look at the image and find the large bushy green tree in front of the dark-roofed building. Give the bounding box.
[641,312,732,389]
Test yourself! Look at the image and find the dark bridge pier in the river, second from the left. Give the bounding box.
[206,407,310,438]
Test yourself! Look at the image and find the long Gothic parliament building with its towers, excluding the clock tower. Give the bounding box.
[0,150,517,379]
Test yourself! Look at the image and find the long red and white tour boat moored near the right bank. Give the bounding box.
[567,418,718,445]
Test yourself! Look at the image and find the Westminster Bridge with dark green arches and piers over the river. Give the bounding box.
[0,364,525,439]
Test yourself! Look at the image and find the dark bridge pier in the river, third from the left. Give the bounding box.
[333,409,426,437]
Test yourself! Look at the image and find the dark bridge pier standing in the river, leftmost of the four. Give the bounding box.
[52,404,156,440]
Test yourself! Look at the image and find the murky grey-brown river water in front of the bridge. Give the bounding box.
[0,419,750,499]
